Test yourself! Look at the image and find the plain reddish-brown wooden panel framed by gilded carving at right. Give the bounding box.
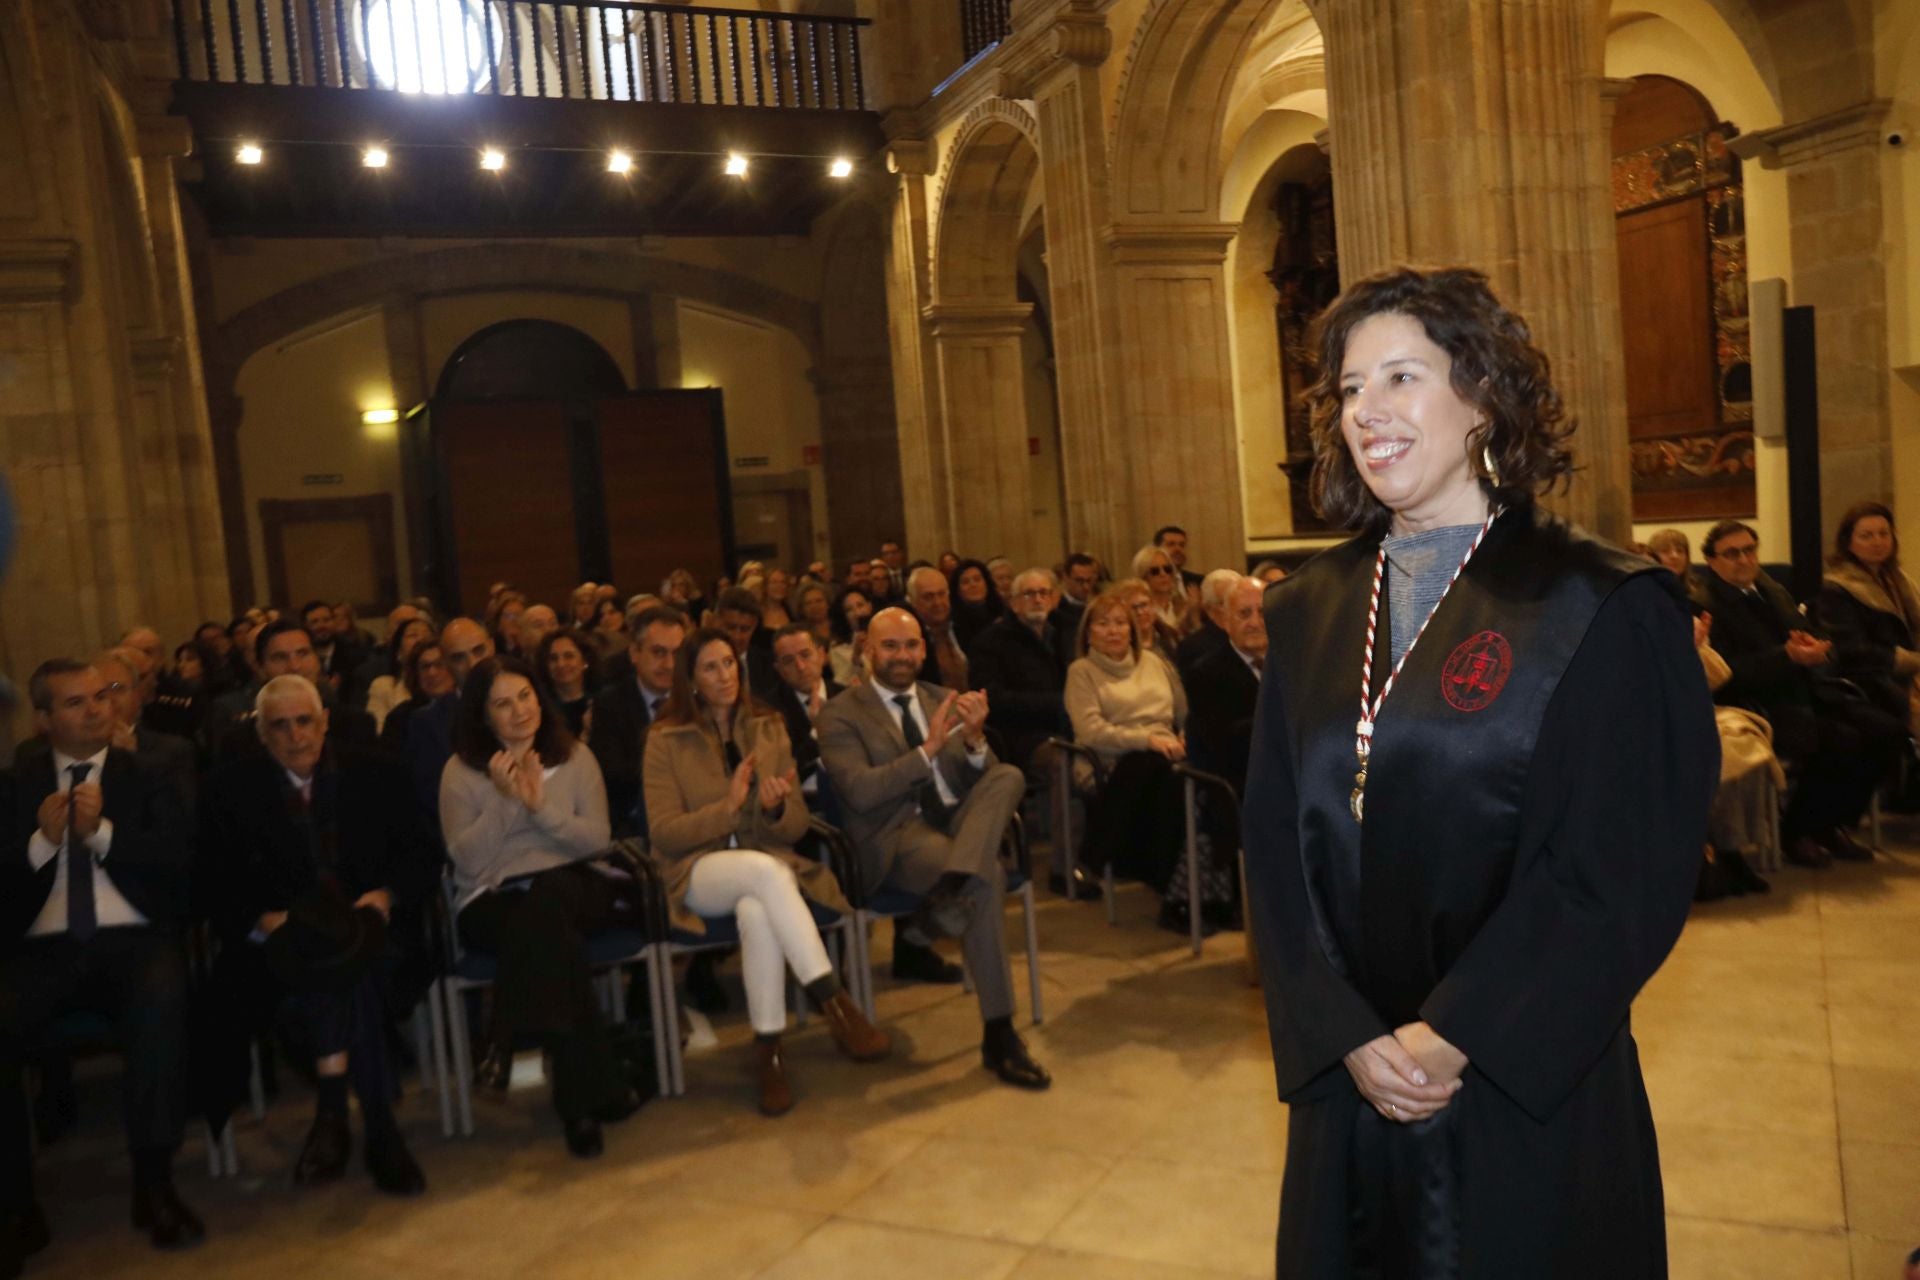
[1617,198,1718,438]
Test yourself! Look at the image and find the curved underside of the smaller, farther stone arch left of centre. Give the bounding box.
[933,98,1041,303]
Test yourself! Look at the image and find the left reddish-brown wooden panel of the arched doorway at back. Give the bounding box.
[434,401,580,612]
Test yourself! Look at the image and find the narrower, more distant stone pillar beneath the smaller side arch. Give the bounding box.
[925,303,1056,564]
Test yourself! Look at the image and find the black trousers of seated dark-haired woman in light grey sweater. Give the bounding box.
[459,864,639,1119]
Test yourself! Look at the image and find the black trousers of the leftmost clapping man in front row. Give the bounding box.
[0,927,186,1217]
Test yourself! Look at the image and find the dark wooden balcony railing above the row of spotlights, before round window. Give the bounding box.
[173,0,871,111]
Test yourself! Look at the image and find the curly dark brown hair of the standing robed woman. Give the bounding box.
[1302,267,1574,533]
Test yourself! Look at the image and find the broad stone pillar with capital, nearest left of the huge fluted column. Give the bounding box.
[1108,221,1246,566]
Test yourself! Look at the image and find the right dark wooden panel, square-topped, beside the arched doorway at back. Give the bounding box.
[593,391,733,593]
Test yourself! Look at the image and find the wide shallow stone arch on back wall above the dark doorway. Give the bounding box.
[213,244,820,370]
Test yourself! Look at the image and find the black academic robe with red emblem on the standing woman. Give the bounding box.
[1244,509,1718,1280]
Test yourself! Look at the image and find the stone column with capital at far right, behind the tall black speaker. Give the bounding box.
[1732,100,1893,526]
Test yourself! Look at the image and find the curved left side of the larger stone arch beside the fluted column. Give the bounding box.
[1112,0,1294,219]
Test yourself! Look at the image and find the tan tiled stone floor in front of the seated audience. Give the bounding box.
[27,827,1920,1280]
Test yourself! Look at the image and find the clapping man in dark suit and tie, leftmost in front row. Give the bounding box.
[0,658,205,1274]
